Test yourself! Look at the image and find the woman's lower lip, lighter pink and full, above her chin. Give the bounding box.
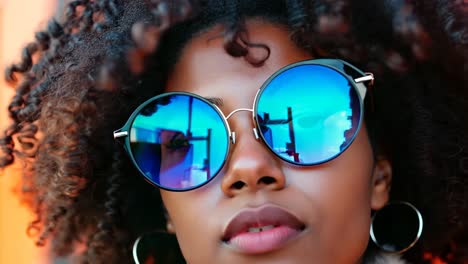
[227,226,302,254]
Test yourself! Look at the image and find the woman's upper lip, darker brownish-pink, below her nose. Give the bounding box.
[222,205,305,241]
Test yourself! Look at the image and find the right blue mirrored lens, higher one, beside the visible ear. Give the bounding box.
[257,64,361,165]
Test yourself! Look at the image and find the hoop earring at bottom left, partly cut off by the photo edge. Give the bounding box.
[132,230,185,264]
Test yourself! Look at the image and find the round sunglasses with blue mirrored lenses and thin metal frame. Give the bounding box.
[114,59,374,191]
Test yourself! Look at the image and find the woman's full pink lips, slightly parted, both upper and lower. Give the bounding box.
[222,205,305,254]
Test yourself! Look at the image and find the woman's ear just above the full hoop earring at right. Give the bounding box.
[371,157,392,210]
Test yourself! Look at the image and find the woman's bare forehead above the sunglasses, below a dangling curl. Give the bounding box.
[166,20,311,95]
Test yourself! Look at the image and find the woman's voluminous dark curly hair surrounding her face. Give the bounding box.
[0,0,468,263]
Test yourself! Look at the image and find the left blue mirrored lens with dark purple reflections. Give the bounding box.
[130,94,228,190]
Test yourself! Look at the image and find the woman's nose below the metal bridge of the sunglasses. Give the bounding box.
[221,113,286,197]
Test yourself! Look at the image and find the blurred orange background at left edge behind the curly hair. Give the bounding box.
[0,0,55,264]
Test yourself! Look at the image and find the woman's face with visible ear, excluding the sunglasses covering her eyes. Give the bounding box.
[161,21,389,264]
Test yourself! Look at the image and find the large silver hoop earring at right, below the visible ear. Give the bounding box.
[370,201,423,254]
